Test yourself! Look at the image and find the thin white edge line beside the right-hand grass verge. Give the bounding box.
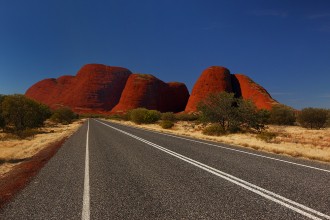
[109,120,330,173]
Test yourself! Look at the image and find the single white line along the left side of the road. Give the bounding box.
[81,119,90,220]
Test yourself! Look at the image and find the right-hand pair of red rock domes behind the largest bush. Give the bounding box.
[185,66,277,112]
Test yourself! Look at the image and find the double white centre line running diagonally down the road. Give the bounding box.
[97,121,330,219]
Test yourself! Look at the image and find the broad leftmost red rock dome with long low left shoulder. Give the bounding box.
[25,64,131,113]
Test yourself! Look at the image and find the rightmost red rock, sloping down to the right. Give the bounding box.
[233,74,278,110]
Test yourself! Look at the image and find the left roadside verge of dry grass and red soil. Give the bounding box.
[0,121,82,208]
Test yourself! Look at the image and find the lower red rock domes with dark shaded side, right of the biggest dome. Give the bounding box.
[111,74,189,113]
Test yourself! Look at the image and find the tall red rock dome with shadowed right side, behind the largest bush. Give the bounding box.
[185,66,233,112]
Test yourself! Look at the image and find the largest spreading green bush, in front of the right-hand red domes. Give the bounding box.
[197,92,264,132]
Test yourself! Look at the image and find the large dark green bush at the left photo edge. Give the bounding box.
[1,95,51,132]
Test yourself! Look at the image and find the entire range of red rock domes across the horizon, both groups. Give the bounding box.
[25,64,277,114]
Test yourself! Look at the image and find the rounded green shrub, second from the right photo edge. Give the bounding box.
[269,104,296,125]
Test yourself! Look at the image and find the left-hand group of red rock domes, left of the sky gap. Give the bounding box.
[25,64,189,114]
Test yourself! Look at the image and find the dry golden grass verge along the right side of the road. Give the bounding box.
[109,120,330,163]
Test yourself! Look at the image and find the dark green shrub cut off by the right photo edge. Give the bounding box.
[297,108,328,129]
